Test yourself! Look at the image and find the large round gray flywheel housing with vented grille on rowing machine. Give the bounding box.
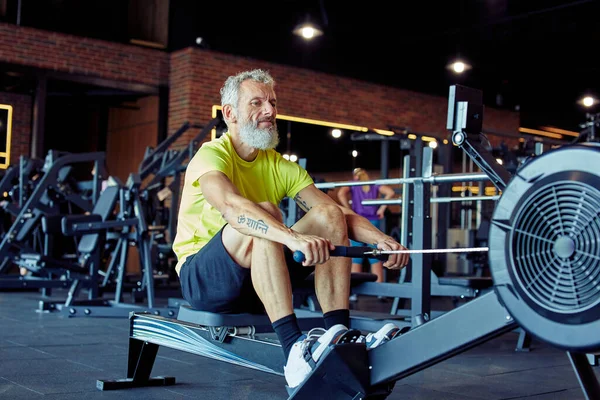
[489,143,600,352]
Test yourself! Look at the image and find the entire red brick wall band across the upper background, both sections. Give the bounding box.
[0,23,519,164]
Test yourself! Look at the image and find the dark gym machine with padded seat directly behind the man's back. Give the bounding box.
[40,118,220,318]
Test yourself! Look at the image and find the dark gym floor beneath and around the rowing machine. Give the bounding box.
[0,292,600,400]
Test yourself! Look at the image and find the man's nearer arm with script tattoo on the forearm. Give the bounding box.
[199,170,335,265]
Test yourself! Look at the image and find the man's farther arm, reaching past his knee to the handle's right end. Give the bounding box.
[294,185,408,268]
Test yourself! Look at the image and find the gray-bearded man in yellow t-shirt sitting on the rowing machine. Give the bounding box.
[173,69,408,388]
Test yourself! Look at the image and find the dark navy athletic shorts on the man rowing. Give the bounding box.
[179,229,314,313]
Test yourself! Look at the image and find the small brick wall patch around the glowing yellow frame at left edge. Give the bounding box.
[0,92,32,164]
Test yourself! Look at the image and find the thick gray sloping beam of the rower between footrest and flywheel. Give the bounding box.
[368,293,517,385]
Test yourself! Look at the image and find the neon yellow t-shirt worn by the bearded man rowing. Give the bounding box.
[173,133,313,273]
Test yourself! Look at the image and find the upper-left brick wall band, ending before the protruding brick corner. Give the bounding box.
[0,23,169,86]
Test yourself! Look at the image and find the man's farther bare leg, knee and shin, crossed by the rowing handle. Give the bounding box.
[292,205,352,314]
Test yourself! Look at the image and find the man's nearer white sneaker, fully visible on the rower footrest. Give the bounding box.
[283,324,348,388]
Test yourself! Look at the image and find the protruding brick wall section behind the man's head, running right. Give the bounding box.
[169,48,519,144]
